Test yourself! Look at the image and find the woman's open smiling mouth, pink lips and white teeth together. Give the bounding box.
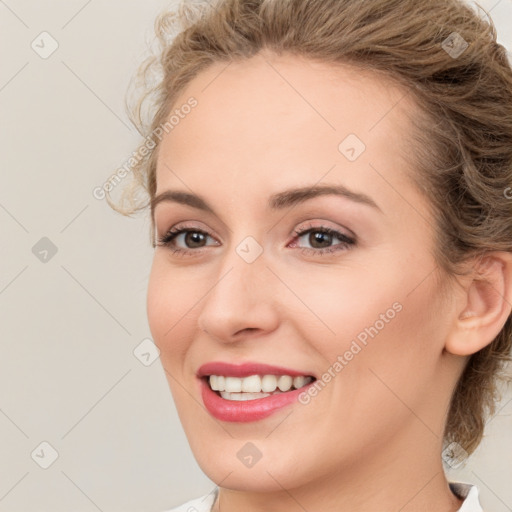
[197,363,316,422]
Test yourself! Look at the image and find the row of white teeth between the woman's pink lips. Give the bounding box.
[209,375,313,400]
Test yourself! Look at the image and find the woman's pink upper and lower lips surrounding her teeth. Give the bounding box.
[198,362,315,423]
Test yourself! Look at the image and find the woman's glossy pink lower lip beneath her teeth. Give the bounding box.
[201,379,313,423]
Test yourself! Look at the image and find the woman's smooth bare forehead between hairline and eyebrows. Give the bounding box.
[157,53,422,212]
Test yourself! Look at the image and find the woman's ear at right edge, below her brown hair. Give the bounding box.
[445,252,512,356]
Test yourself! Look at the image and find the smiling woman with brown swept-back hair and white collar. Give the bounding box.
[108,0,512,512]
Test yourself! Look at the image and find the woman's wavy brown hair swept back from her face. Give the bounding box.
[107,0,512,454]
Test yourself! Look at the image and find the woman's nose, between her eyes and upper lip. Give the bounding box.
[198,250,279,343]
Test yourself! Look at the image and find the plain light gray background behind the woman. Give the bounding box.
[0,0,512,512]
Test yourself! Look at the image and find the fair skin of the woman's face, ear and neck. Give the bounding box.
[147,53,510,512]
